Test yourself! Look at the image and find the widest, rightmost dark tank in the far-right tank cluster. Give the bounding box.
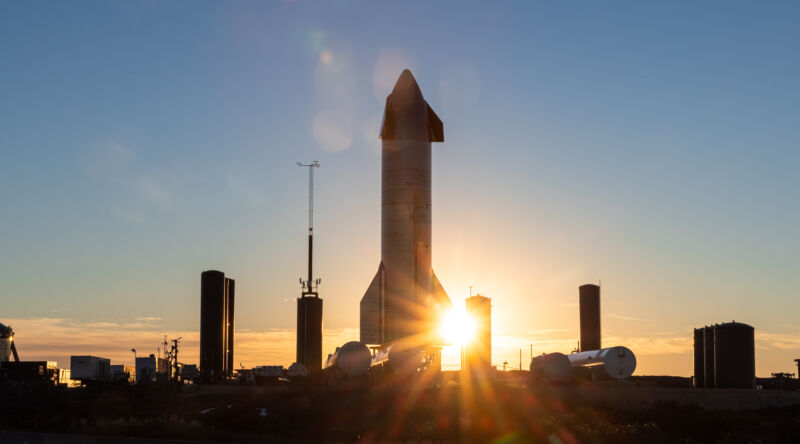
[714,322,756,388]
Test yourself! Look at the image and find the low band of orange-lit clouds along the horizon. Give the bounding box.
[5,317,800,374]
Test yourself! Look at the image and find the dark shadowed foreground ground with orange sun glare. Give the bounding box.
[0,372,800,443]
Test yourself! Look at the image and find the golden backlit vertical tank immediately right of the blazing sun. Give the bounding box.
[461,295,492,374]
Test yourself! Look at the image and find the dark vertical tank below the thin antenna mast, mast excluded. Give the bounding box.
[297,295,322,372]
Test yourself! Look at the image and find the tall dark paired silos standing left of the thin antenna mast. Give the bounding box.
[200,270,236,382]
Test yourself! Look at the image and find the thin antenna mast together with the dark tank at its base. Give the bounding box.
[297,160,322,372]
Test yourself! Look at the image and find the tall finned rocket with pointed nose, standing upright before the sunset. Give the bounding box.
[360,69,452,345]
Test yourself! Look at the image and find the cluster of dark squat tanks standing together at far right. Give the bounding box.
[694,321,756,388]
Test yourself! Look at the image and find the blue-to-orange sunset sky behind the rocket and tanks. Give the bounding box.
[0,0,800,376]
